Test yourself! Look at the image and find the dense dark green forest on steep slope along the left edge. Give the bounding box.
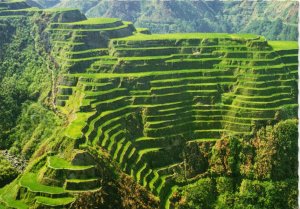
[0,18,51,152]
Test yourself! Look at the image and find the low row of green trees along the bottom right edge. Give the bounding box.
[175,177,298,209]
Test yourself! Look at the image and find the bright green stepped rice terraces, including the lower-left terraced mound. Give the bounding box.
[0,1,298,208]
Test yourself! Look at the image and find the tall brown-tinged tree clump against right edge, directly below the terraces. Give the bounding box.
[253,119,298,180]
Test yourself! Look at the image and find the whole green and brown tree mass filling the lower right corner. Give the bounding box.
[173,119,298,209]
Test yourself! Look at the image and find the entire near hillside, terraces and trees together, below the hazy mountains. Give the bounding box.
[0,0,298,209]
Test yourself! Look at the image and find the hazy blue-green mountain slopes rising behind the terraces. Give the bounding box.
[31,0,299,40]
